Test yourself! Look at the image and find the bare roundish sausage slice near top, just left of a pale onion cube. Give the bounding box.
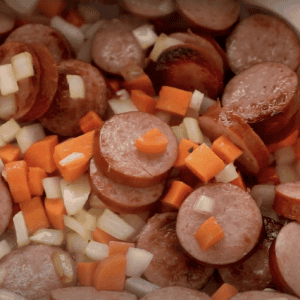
[92,19,145,75]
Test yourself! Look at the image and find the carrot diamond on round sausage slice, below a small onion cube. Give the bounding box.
[195,217,224,250]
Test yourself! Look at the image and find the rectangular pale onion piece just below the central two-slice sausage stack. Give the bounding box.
[97,209,134,241]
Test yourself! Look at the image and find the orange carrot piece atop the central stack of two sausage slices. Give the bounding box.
[135,128,168,154]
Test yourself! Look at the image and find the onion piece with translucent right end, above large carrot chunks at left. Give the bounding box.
[16,123,46,153]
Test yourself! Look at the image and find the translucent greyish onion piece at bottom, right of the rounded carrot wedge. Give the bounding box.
[124,277,160,299]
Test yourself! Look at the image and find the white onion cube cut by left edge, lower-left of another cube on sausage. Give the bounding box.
[0,64,19,96]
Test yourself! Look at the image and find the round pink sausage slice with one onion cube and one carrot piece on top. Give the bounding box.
[176,183,262,266]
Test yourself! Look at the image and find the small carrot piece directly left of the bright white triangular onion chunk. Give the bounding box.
[45,198,67,230]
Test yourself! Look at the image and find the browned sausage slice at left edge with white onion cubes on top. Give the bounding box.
[0,42,41,120]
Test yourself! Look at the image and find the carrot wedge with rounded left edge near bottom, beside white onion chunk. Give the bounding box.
[93,254,126,291]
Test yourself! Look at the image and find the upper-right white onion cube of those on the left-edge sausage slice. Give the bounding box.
[11,52,34,81]
